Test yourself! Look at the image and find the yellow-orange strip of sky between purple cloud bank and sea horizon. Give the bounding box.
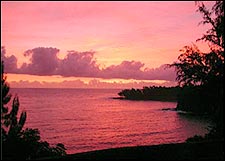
[6,73,176,88]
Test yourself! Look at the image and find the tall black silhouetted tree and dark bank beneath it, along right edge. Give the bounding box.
[169,1,224,141]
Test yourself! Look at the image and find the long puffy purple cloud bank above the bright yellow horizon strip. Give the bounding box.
[1,47,176,81]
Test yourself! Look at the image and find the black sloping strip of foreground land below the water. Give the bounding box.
[37,140,224,161]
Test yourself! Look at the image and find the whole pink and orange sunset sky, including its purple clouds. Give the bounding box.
[1,1,214,88]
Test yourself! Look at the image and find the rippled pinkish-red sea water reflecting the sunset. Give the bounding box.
[10,88,210,154]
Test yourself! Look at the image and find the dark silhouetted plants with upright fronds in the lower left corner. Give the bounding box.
[1,62,66,160]
